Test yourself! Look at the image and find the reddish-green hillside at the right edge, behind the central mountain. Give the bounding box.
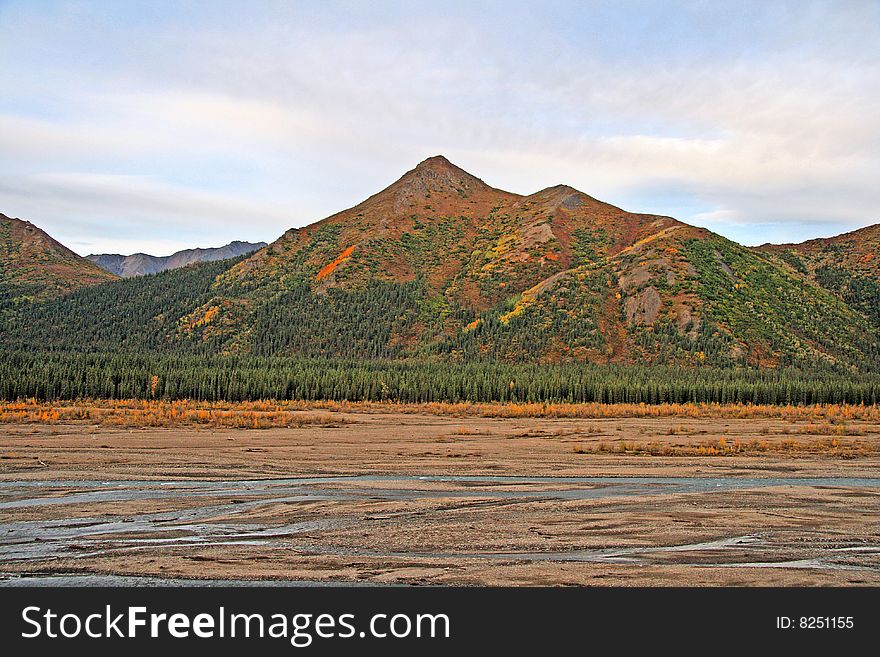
[756,224,880,327]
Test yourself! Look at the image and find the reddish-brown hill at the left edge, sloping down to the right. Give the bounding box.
[0,214,116,308]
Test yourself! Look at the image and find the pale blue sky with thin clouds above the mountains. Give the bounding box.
[0,0,880,255]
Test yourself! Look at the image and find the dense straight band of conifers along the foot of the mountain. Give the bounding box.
[0,350,880,404]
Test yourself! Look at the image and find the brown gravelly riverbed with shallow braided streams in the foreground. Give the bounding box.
[0,413,880,585]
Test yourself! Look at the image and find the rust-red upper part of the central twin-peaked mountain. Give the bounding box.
[225,156,678,309]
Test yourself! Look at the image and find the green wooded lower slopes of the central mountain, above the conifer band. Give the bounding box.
[0,231,880,371]
